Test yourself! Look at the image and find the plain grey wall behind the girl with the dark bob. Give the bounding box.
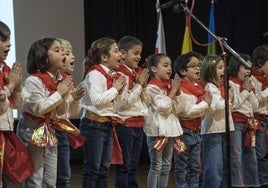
[13,0,85,83]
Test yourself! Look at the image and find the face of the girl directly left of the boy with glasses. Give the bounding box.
[151,57,172,82]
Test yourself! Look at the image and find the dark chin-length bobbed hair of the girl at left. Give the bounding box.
[27,38,58,74]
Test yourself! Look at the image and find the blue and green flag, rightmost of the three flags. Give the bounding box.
[207,0,216,54]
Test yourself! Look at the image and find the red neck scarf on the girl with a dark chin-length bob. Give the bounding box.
[31,71,59,95]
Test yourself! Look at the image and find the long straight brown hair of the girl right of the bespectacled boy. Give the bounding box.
[200,54,222,87]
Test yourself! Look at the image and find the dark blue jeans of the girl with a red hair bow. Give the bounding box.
[80,118,113,188]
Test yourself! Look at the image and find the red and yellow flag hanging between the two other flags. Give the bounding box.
[181,15,193,54]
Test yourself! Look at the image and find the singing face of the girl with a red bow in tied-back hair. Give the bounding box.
[104,44,122,70]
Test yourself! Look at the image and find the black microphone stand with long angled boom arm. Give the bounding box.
[160,0,251,187]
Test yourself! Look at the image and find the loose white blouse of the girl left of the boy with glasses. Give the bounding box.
[143,84,186,137]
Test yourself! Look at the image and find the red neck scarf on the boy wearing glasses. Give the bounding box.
[181,78,205,104]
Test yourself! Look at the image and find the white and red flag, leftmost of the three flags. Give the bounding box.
[154,5,166,54]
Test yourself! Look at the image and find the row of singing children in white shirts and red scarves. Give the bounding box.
[0,19,268,188]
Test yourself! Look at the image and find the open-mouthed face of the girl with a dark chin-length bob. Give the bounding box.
[47,41,65,75]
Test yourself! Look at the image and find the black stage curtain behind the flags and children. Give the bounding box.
[84,0,268,61]
